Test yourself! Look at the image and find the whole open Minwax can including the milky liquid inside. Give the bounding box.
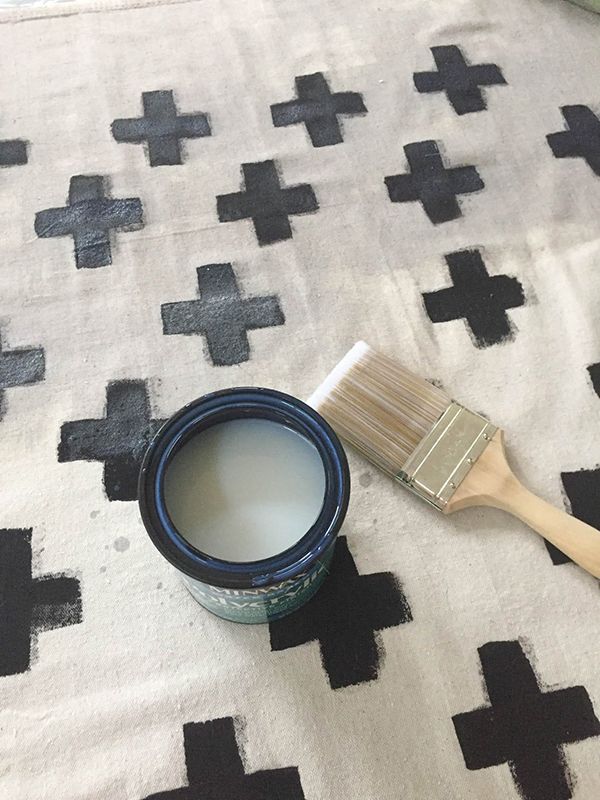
[138,388,350,623]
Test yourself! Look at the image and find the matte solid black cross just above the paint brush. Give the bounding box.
[423,250,525,347]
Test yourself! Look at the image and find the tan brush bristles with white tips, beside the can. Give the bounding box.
[308,342,451,476]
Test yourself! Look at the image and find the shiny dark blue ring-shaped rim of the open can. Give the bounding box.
[138,387,350,589]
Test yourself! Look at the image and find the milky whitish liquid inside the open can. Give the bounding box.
[164,419,325,562]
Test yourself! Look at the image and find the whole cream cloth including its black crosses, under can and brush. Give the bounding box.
[0,0,600,800]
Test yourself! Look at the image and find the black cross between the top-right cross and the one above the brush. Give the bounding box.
[384,140,485,225]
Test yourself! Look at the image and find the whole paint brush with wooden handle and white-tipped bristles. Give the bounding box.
[309,342,600,578]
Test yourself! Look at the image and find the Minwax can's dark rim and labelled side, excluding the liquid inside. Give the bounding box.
[138,388,350,623]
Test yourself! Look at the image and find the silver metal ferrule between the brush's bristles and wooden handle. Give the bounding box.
[396,402,497,511]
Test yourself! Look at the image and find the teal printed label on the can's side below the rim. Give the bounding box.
[183,547,333,623]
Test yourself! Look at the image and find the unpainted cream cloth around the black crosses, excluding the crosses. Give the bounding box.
[0,0,600,800]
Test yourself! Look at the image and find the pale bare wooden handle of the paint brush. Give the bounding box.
[445,431,600,578]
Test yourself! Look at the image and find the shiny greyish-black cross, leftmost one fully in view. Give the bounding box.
[35,175,144,269]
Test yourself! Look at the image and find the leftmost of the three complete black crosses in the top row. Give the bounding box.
[111,91,211,167]
